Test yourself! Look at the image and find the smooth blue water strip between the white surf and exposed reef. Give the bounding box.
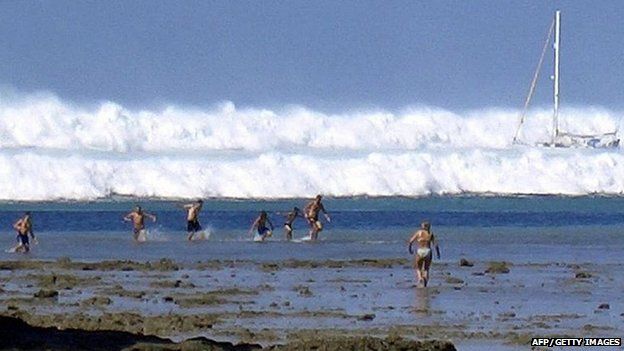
[0,196,624,263]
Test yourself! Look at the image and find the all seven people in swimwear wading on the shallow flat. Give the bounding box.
[7,195,440,287]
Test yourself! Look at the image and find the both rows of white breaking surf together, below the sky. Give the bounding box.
[0,94,624,200]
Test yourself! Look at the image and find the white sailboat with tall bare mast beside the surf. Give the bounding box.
[513,10,620,148]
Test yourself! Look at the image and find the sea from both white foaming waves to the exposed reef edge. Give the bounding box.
[0,93,624,262]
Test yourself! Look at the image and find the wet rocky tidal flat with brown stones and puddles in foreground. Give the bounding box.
[0,258,624,350]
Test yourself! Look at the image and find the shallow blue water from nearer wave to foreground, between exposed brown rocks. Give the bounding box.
[0,197,624,350]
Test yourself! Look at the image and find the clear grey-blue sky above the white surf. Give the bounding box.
[0,0,624,110]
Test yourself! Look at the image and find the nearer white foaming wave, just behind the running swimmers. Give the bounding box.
[0,148,624,201]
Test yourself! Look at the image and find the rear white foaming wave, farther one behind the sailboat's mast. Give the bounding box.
[0,91,621,153]
